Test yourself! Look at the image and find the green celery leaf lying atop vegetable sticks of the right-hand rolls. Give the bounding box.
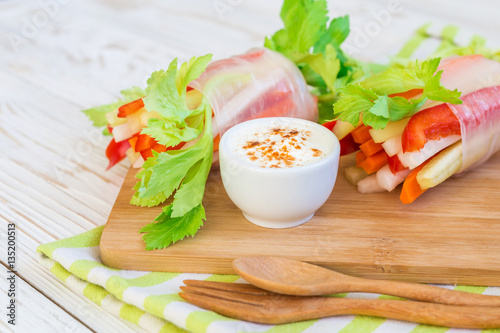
[333,58,462,129]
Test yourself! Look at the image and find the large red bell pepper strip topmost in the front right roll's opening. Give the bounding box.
[401,104,460,153]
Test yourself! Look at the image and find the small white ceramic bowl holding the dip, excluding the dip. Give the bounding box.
[219,118,340,228]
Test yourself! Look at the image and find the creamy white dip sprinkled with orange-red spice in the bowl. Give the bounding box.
[230,124,327,168]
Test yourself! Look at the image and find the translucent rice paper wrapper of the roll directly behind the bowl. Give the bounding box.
[190,48,318,137]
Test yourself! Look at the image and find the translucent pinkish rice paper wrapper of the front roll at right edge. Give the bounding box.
[448,86,500,172]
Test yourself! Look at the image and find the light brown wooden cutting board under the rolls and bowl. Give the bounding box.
[100,154,500,286]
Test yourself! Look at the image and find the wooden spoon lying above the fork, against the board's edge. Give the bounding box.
[233,257,500,306]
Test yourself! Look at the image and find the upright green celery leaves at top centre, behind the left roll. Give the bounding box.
[264,0,357,100]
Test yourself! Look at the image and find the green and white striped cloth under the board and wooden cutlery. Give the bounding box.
[37,227,500,333]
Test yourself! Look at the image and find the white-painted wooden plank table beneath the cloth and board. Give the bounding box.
[0,0,500,332]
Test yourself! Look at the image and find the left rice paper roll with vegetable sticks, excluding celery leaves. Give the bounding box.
[108,48,318,168]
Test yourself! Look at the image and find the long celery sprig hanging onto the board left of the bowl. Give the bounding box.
[130,54,213,250]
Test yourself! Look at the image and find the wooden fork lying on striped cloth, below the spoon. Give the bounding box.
[179,280,500,328]
